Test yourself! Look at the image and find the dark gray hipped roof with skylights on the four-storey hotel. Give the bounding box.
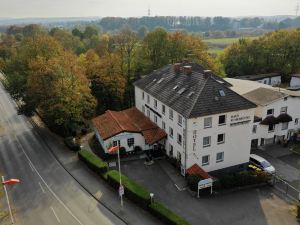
[134,63,256,118]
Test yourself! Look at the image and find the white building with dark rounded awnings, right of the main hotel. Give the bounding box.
[225,78,300,147]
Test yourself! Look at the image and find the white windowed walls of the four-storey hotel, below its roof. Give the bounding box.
[135,87,254,172]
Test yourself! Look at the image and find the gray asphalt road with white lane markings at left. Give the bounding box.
[0,84,124,225]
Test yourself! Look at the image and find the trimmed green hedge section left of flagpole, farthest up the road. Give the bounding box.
[78,149,108,176]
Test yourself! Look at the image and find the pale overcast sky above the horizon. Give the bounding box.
[0,0,300,18]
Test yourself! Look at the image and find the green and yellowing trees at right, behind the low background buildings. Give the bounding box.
[221,29,300,79]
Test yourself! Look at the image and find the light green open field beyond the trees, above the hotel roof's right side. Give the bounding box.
[203,36,258,55]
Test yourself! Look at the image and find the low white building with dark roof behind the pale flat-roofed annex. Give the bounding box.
[236,73,281,86]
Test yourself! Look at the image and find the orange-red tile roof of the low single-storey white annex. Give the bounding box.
[92,107,167,144]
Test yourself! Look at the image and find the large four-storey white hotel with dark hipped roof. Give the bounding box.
[134,63,256,173]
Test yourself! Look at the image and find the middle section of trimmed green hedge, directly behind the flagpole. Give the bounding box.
[107,170,150,209]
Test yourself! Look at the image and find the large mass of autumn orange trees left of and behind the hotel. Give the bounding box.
[0,25,223,135]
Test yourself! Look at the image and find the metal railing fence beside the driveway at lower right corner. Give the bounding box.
[271,174,300,201]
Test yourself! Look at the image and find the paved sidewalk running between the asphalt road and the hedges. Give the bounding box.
[29,117,161,225]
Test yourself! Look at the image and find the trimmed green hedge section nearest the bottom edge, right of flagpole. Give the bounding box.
[149,202,191,225]
